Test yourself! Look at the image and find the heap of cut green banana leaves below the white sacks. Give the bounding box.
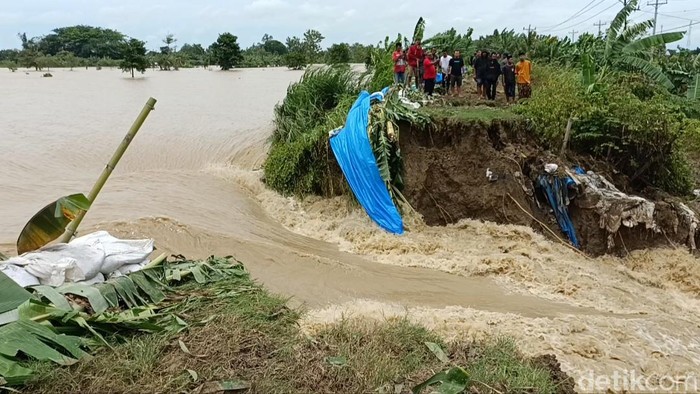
[0,257,247,386]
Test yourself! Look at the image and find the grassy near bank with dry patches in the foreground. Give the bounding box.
[23,258,573,393]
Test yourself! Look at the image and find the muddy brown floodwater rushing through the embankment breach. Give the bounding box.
[0,69,700,392]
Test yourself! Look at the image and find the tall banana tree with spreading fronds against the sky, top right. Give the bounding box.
[581,0,684,90]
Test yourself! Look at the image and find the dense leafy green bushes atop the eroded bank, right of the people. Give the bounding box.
[517,66,700,194]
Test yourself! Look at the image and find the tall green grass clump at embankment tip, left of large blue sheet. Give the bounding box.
[264,67,359,196]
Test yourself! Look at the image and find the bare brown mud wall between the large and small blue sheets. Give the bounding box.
[401,121,534,226]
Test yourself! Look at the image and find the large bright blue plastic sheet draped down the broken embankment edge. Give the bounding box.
[331,89,403,234]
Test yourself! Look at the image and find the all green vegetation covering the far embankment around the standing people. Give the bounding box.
[265,1,700,200]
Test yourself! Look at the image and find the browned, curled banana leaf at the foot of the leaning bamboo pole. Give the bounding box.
[17,194,90,254]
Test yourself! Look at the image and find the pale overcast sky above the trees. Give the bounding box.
[0,0,700,49]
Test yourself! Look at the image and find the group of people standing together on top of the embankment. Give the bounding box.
[393,40,532,102]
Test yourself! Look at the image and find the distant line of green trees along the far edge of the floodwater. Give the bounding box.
[0,25,369,74]
